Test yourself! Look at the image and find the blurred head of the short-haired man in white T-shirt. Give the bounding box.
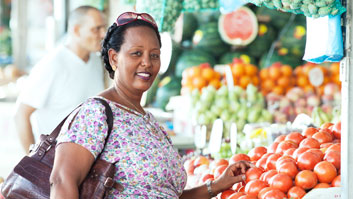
[68,6,106,52]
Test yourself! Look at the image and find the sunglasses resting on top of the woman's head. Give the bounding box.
[115,12,158,29]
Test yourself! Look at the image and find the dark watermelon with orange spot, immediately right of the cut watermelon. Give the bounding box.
[247,23,277,58]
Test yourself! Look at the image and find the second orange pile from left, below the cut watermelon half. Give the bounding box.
[230,58,260,89]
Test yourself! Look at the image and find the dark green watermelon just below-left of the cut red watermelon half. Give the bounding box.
[192,22,229,57]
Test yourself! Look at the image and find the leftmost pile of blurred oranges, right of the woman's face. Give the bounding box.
[181,63,221,92]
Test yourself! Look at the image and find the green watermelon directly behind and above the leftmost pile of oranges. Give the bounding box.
[175,49,216,77]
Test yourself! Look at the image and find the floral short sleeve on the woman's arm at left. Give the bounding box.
[57,98,108,158]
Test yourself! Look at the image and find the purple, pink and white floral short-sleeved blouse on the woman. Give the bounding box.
[58,97,186,199]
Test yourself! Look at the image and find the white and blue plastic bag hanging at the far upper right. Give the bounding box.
[303,16,343,63]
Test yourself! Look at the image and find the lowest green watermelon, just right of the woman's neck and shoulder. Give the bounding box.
[154,76,181,110]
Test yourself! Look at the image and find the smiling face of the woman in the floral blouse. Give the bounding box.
[113,26,161,93]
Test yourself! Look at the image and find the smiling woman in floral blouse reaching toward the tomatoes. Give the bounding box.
[50,12,250,199]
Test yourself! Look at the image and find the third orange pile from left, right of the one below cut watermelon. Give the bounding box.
[260,62,295,95]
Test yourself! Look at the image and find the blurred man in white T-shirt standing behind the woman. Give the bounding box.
[14,6,106,153]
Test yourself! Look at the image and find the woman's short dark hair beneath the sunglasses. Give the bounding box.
[102,19,162,79]
